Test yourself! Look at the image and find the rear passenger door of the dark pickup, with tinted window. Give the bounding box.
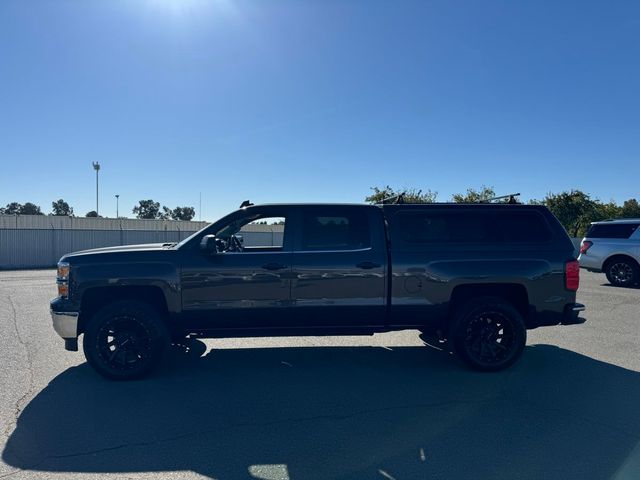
[291,205,387,327]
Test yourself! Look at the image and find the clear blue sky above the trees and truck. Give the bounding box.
[0,0,640,220]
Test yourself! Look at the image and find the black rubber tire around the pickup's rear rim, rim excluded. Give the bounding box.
[450,297,527,372]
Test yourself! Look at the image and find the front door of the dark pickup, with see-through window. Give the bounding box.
[181,207,293,330]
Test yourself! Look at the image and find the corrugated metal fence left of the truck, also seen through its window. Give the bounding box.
[0,215,283,269]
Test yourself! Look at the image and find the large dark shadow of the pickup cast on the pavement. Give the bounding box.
[2,345,640,480]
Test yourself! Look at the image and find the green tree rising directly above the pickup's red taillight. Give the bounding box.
[542,190,603,237]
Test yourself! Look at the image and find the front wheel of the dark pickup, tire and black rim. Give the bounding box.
[82,300,170,380]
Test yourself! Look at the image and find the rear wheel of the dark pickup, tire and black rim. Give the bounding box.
[449,297,527,372]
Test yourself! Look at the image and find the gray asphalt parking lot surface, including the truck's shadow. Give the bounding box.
[0,270,640,480]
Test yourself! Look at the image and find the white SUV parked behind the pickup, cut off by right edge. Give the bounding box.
[578,218,640,287]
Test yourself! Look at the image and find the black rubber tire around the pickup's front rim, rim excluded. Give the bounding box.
[82,300,170,380]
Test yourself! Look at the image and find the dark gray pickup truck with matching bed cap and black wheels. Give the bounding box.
[51,204,584,379]
